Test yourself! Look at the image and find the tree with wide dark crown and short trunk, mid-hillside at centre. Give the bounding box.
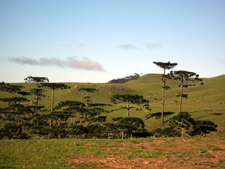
[111,94,149,117]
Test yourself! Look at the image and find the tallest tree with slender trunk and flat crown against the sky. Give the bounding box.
[153,62,177,125]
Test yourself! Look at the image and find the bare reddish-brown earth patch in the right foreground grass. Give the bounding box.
[65,139,225,169]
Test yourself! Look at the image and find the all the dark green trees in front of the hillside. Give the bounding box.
[0,65,217,139]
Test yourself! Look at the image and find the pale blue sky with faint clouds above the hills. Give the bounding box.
[0,0,225,83]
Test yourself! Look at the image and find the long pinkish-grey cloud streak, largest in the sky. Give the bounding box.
[9,56,105,71]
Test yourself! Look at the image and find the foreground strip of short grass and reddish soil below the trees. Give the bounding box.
[0,138,225,168]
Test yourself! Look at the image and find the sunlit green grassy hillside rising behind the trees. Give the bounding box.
[0,74,225,130]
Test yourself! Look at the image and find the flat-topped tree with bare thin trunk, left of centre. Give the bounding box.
[41,83,70,112]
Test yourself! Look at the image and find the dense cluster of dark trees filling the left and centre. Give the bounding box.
[0,76,148,139]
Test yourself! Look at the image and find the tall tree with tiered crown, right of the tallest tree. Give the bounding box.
[164,70,202,112]
